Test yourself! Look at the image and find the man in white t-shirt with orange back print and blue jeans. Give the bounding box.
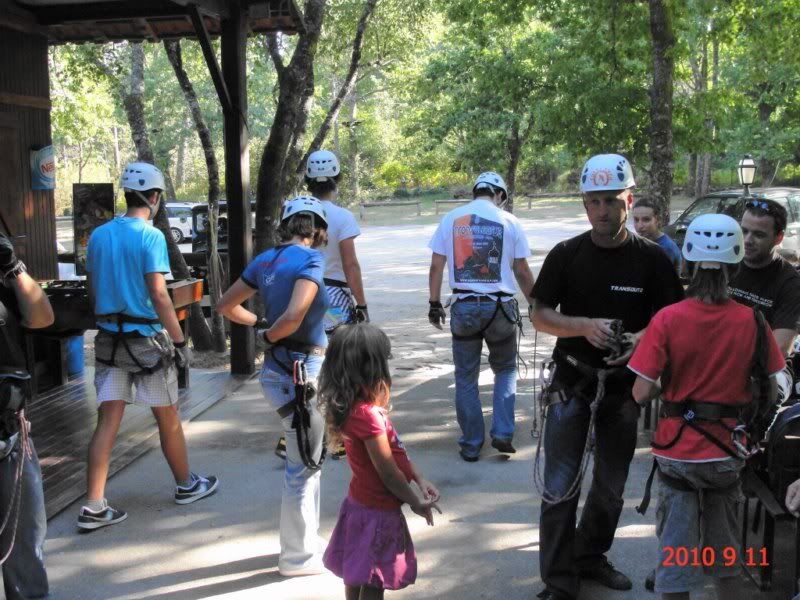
[428,172,533,462]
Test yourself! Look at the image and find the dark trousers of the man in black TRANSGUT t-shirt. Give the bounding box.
[539,387,639,598]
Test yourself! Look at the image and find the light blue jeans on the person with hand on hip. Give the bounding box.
[261,348,325,571]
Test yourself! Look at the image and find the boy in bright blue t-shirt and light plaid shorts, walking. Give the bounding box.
[77,162,219,531]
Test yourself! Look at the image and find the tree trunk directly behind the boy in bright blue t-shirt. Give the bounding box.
[120,43,211,350]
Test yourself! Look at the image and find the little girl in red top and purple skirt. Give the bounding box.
[319,323,441,600]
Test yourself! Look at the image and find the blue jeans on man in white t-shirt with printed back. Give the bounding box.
[450,296,519,456]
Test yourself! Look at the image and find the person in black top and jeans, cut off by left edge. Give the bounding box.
[0,233,53,600]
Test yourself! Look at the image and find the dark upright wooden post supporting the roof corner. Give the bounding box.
[220,0,255,375]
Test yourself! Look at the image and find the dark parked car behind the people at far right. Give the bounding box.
[664,187,800,262]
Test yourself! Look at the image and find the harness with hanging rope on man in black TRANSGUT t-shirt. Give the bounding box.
[533,320,630,504]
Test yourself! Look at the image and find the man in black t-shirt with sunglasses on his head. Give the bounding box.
[728,198,800,355]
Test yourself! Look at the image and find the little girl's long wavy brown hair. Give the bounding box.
[319,323,392,448]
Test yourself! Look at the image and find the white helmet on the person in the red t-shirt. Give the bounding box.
[683,214,744,268]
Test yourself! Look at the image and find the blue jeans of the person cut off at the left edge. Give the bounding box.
[0,441,50,600]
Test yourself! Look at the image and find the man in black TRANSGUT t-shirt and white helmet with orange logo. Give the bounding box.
[531,154,683,600]
